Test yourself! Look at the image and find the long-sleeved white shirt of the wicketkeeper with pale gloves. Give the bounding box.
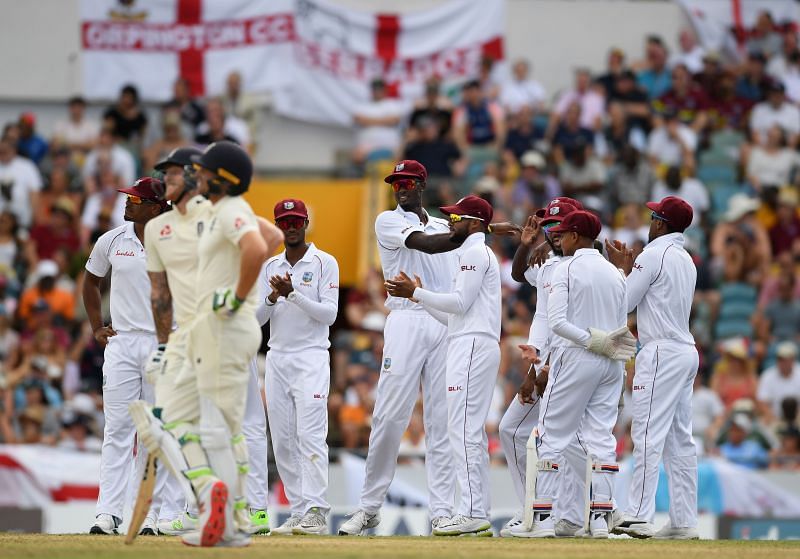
[547,248,628,347]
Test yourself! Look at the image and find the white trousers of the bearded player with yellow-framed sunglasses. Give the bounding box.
[447,336,500,518]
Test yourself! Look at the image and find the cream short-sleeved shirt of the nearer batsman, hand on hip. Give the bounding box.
[196,196,258,315]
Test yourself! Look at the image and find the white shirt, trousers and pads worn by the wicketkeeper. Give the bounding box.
[536,248,626,521]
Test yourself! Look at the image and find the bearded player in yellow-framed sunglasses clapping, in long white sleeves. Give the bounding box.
[386,196,502,536]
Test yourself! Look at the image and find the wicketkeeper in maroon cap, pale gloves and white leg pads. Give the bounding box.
[532,210,636,538]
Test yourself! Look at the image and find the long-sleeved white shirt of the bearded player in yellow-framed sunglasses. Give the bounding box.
[414,233,502,341]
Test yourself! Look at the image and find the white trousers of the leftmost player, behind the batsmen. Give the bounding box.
[95,332,168,518]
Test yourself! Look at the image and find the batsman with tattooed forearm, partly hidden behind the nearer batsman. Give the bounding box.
[145,147,282,535]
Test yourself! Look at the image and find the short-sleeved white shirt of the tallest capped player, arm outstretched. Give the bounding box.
[375,206,458,310]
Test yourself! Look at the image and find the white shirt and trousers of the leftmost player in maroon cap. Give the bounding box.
[86,222,167,518]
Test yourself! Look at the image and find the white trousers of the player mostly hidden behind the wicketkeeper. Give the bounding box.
[499,396,586,524]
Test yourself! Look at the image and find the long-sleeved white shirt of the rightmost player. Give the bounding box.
[626,233,697,345]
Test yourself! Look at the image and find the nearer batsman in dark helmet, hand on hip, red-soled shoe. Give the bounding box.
[131,141,268,547]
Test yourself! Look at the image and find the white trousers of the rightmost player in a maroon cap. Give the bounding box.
[627,341,699,528]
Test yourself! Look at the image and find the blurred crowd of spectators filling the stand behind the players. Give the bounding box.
[0,14,800,476]
